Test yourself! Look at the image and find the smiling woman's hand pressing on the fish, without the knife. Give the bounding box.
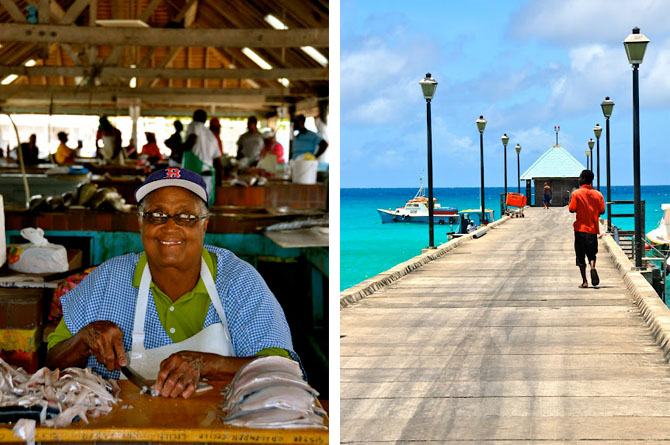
[154,351,204,399]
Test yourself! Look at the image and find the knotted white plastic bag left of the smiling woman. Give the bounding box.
[7,227,68,273]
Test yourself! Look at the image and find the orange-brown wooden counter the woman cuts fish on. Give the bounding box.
[0,380,328,444]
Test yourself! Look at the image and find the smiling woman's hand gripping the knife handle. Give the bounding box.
[79,321,127,371]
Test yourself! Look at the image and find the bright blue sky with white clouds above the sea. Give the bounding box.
[340,0,670,187]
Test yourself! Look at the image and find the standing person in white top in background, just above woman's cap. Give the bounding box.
[182,110,223,205]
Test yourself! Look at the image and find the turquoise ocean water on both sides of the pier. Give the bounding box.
[340,185,670,290]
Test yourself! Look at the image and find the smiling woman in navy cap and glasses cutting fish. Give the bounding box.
[47,167,298,398]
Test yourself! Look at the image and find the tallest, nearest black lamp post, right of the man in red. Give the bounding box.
[623,26,649,269]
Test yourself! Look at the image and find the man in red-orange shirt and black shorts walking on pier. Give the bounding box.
[568,170,605,287]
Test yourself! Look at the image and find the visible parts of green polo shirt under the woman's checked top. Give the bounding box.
[47,247,290,358]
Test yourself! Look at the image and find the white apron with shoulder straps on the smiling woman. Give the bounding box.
[122,259,235,380]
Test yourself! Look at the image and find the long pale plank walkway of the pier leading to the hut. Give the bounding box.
[340,208,670,444]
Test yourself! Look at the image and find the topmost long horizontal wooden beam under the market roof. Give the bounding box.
[0,23,328,48]
